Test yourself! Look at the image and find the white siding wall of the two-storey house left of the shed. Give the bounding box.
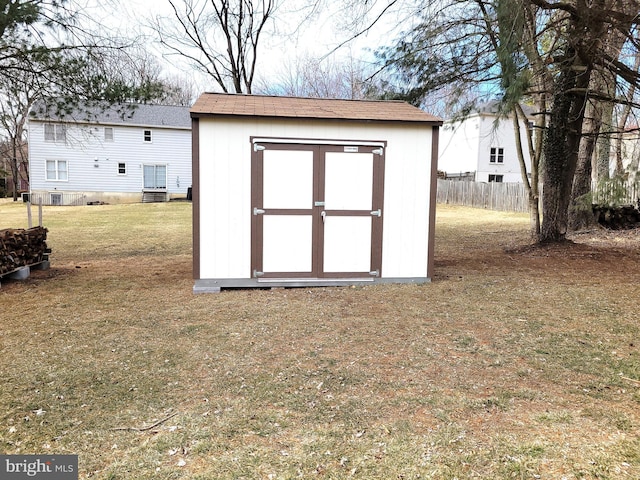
[29,120,191,201]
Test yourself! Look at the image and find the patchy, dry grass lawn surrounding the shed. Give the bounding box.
[0,201,640,480]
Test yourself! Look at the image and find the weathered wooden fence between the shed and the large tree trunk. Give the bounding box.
[436,179,529,212]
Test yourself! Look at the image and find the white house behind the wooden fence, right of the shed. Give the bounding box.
[438,102,531,183]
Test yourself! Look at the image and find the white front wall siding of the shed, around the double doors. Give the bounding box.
[199,118,431,279]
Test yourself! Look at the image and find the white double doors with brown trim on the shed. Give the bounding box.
[251,142,384,279]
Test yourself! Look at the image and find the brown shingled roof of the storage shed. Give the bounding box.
[191,93,442,125]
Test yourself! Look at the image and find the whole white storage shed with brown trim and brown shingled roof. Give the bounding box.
[191,93,442,293]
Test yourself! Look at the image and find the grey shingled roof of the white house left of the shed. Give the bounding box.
[30,102,191,129]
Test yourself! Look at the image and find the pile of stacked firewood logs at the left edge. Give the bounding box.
[0,227,51,276]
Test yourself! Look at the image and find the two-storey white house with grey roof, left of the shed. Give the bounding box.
[28,104,191,205]
